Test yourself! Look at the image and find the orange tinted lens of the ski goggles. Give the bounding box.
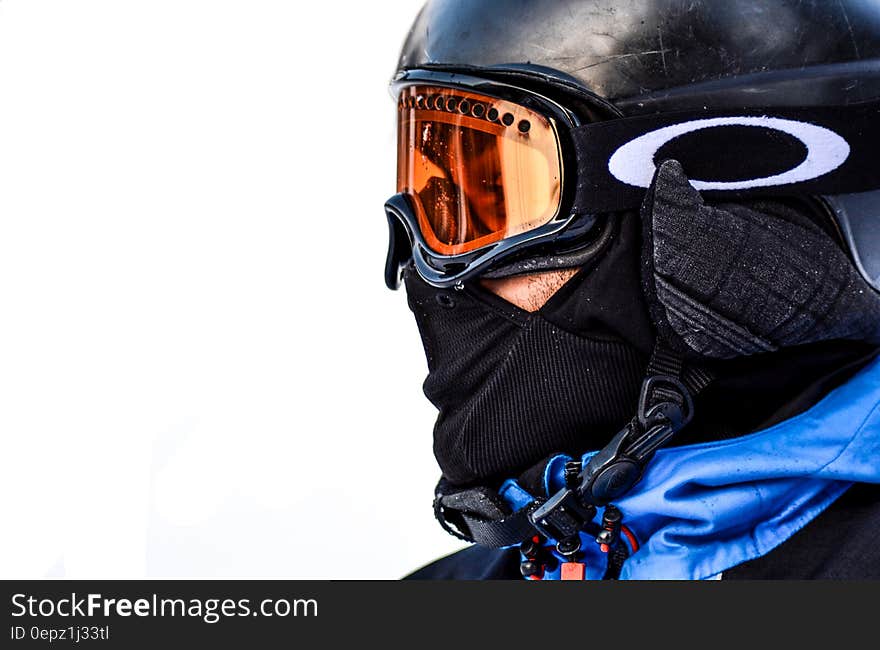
[397,86,562,255]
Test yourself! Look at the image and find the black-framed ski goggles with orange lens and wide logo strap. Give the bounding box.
[385,70,880,289]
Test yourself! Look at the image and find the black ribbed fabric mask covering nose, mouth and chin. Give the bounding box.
[405,218,653,485]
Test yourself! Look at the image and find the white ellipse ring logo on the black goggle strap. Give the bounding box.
[608,117,850,190]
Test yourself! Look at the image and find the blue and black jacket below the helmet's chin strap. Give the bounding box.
[412,360,880,579]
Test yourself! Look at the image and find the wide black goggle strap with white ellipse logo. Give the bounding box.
[572,100,880,214]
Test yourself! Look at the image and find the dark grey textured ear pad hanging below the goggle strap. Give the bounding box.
[642,160,880,359]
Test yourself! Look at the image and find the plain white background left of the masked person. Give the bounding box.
[0,0,468,579]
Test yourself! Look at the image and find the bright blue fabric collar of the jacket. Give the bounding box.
[501,360,880,580]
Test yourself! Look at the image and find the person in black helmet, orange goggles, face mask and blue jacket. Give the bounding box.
[385,0,880,580]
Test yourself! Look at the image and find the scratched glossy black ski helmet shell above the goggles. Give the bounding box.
[398,0,880,289]
